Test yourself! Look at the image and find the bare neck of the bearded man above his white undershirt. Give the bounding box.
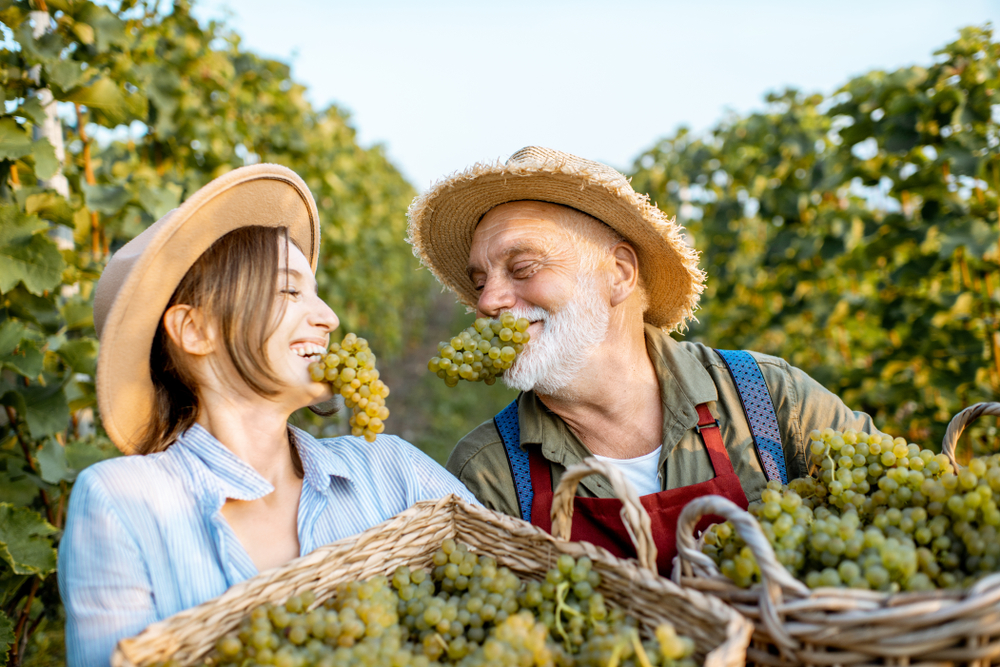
[538,320,663,459]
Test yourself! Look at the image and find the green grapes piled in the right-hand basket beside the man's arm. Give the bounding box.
[704,429,1000,592]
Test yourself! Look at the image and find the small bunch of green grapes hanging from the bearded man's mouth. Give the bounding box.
[427,313,531,387]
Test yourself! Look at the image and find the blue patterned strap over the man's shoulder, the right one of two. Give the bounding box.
[716,350,788,484]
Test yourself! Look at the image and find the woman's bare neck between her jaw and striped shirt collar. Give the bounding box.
[197,390,297,487]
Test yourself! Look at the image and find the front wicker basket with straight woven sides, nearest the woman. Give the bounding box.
[111,460,752,667]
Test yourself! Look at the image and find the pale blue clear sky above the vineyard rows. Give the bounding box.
[196,0,1000,190]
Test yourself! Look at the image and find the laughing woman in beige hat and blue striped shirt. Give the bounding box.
[59,165,472,666]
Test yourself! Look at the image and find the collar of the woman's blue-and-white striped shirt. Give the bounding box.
[173,424,350,500]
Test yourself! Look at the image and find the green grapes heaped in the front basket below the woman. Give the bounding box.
[195,540,696,667]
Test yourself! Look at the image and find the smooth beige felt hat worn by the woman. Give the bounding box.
[94,164,320,454]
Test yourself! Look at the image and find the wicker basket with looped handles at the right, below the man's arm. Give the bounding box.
[673,403,1000,667]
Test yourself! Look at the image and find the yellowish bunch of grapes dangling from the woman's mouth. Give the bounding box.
[309,333,389,442]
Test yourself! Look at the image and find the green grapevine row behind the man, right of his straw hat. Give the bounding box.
[632,27,1000,450]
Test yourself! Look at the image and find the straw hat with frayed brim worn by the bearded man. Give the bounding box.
[407,146,705,331]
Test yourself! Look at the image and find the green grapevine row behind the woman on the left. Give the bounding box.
[0,0,430,664]
